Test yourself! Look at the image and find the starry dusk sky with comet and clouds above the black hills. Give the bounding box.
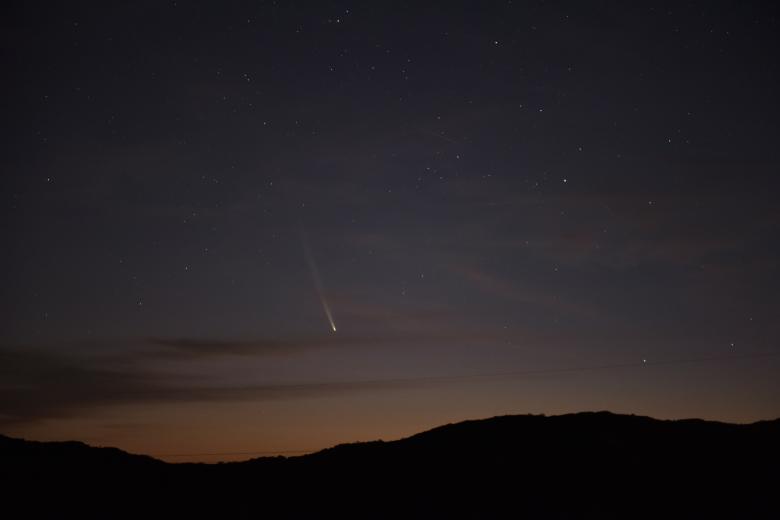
[0,0,780,460]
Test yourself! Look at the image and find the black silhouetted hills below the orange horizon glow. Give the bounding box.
[0,412,780,518]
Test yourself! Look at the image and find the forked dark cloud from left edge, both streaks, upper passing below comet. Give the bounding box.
[0,333,506,426]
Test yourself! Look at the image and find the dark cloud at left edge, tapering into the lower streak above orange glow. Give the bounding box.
[0,348,420,426]
